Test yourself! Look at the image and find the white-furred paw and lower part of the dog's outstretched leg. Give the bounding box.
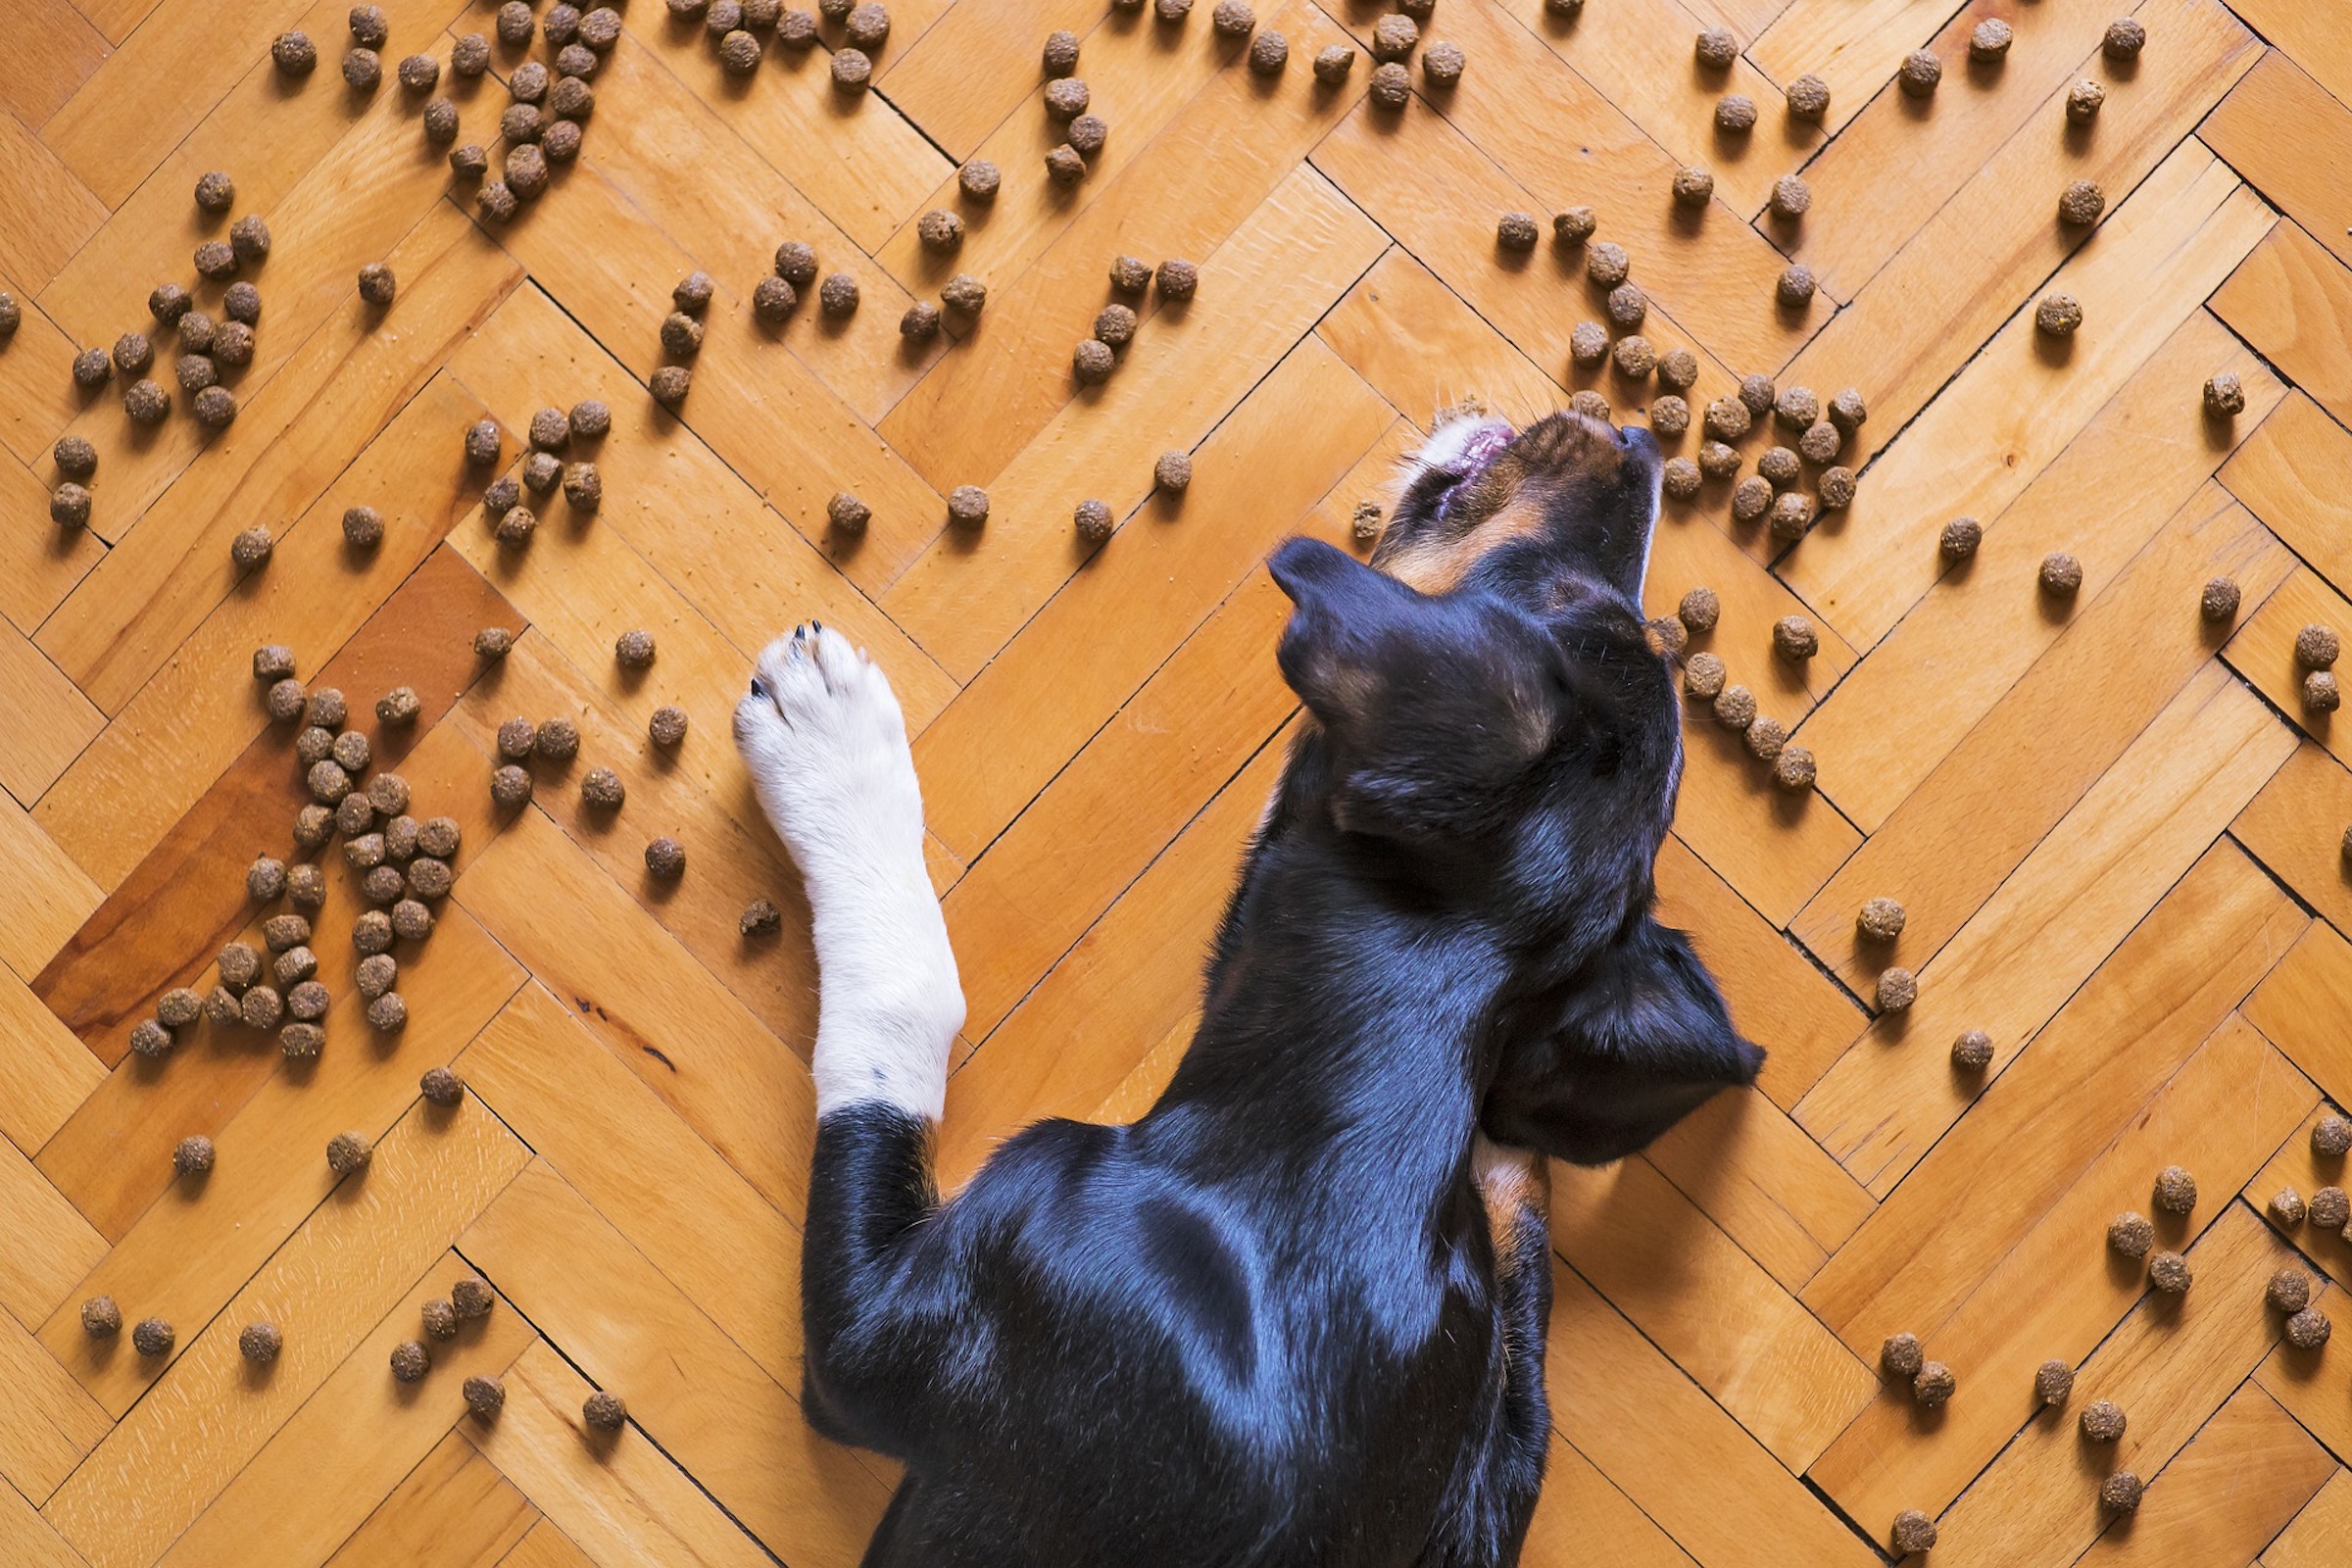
[734,625,964,1121]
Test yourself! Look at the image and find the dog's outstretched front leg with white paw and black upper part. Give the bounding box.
[734,625,964,1457]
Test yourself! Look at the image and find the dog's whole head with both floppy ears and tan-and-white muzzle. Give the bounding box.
[1272,414,1762,1163]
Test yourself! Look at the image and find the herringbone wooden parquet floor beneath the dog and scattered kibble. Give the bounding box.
[0,0,2352,1568]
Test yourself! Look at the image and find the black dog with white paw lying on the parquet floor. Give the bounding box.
[736,414,1762,1568]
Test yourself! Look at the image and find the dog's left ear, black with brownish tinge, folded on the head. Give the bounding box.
[1268,538,1571,837]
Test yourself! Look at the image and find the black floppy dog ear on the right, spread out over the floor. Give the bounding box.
[1482,914,1764,1166]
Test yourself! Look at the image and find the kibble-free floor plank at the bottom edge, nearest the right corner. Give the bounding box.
[2080,1385,2340,1568]
